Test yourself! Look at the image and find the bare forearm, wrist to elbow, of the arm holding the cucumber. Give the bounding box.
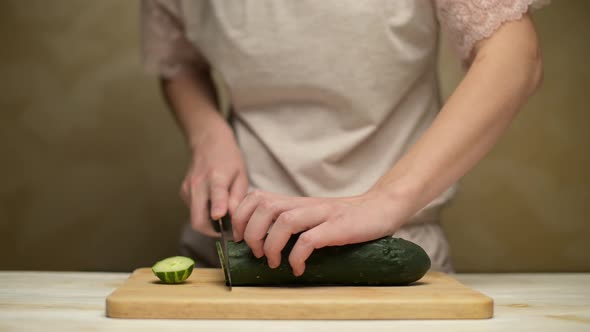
[372,16,542,217]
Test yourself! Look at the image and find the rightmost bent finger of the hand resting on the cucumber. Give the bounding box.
[289,221,347,276]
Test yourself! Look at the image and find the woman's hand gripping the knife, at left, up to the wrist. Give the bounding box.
[180,118,248,237]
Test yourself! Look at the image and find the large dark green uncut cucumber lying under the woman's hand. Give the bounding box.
[226,236,431,286]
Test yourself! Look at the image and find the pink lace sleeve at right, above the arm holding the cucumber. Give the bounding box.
[435,0,550,62]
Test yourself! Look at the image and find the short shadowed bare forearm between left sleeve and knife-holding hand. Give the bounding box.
[161,68,231,150]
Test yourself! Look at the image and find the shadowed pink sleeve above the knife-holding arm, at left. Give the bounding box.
[141,0,203,78]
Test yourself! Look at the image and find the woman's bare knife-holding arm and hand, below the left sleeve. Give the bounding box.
[161,67,248,236]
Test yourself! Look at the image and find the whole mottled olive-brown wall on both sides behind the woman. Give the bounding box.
[0,0,590,271]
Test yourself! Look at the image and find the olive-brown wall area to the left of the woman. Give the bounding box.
[0,0,186,270]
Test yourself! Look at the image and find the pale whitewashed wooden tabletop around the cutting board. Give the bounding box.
[0,271,590,332]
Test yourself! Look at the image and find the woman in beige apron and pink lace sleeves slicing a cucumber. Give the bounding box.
[142,0,542,275]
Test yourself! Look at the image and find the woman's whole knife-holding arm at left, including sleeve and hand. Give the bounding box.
[141,0,248,236]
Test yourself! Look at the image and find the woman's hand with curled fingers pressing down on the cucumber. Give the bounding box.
[232,191,412,276]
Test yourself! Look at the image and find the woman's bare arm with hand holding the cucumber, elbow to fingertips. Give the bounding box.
[232,16,542,275]
